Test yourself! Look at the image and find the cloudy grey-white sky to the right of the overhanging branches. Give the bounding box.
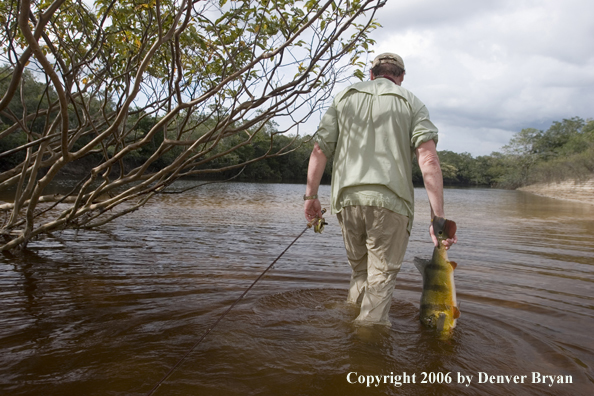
[356,0,594,156]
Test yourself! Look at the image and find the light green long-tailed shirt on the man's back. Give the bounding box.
[316,78,437,233]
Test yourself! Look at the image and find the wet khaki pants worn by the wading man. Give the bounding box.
[337,206,409,326]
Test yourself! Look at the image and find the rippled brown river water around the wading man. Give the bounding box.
[0,182,594,395]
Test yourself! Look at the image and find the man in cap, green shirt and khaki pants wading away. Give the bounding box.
[304,53,457,326]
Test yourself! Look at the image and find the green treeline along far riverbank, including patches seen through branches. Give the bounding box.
[0,72,594,189]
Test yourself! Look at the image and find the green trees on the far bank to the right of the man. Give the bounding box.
[413,117,594,188]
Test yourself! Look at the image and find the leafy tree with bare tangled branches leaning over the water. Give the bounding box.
[0,0,385,250]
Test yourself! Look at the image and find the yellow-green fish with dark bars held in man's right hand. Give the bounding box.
[414,220,460,333]
